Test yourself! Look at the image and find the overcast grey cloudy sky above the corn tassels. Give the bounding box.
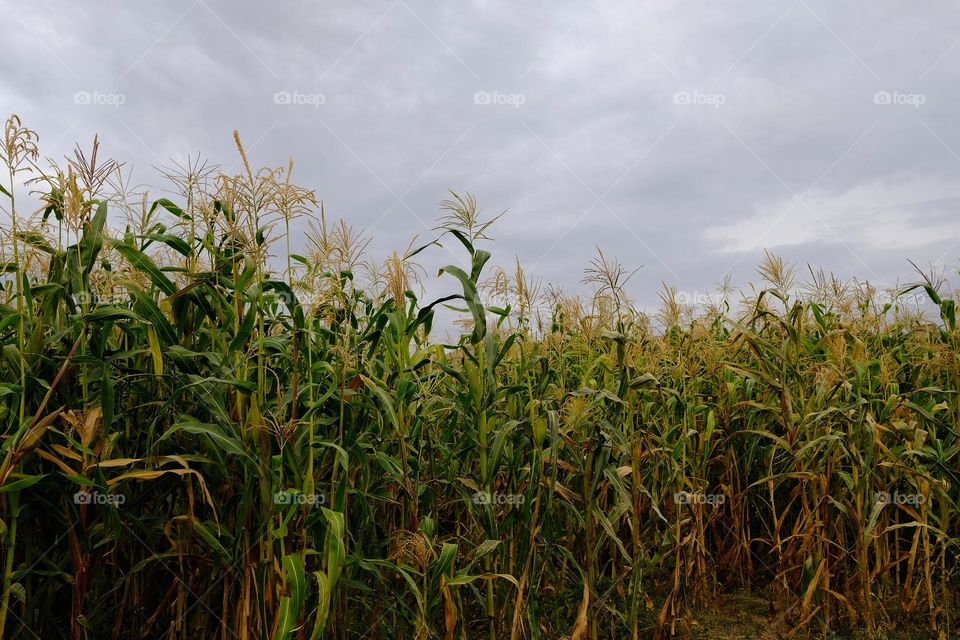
[0,0,960,316]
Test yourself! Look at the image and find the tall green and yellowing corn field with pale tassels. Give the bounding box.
[0,116,960,640]
